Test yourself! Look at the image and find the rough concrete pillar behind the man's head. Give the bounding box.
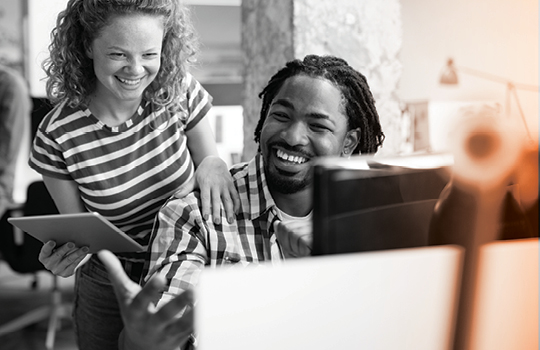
[242,0,408,160]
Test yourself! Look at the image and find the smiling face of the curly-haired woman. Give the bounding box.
[88,14,164,103]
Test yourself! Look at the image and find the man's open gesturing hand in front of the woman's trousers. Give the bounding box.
[98,251,193,350]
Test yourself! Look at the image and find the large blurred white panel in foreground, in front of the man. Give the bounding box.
[195,246,461,350]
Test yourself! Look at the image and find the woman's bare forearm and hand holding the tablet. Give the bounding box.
[39,176,89,277]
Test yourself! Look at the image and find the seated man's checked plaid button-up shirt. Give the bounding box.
[143,154,282,307]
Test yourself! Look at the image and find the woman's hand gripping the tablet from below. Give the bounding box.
[38,241,90,277]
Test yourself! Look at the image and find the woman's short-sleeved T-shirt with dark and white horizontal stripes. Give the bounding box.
[29,75,212,254]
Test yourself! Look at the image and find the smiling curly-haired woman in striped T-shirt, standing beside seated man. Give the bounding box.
[25,0,238,350]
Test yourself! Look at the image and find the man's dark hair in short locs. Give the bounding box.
[255,55,384,154]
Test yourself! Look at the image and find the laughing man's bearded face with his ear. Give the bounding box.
[260,75,358,194]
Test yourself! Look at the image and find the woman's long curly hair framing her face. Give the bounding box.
[43,0,198,111]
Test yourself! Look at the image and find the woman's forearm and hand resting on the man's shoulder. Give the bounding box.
[184,118,240,223]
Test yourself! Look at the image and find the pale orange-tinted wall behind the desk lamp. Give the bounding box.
[398,0,539,139]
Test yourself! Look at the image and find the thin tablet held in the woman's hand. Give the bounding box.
[8,213,144,253]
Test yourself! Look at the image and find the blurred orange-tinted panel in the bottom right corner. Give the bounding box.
[469,238,539,350]
